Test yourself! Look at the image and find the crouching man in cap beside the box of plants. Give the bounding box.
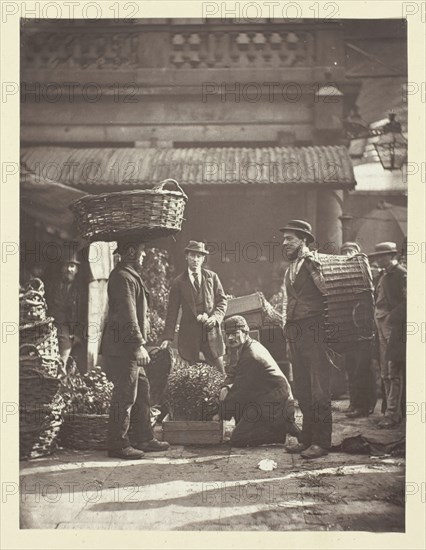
[219,315,300,447]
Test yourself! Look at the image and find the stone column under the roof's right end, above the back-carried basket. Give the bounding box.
[316,189,343,254]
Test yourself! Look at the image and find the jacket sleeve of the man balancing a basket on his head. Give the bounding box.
[111,274,146,349]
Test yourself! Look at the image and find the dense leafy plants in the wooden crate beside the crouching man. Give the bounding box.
[166,362,225,420]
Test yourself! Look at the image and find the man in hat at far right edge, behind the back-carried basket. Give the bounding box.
[369,242,407,428]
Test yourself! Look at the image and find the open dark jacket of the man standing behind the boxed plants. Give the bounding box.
[163,269,228,360]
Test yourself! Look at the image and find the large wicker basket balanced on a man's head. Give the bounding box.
[70,179,188,242]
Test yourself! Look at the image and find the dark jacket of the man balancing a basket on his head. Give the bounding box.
[100,263,149,359]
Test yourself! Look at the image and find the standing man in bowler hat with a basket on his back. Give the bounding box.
[280,220,332,459]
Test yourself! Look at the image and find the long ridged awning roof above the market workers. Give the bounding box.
[21,146,355,188]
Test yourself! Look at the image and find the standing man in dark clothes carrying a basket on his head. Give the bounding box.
[101,239,169,460]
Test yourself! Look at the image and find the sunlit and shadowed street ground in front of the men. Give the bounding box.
[21,401,405,532]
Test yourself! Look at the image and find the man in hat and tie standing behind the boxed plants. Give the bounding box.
[161,241,228,373]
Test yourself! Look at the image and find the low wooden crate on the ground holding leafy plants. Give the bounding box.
[163,415,225,445]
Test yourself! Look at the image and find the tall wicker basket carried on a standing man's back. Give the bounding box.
[320,254,374,353]
